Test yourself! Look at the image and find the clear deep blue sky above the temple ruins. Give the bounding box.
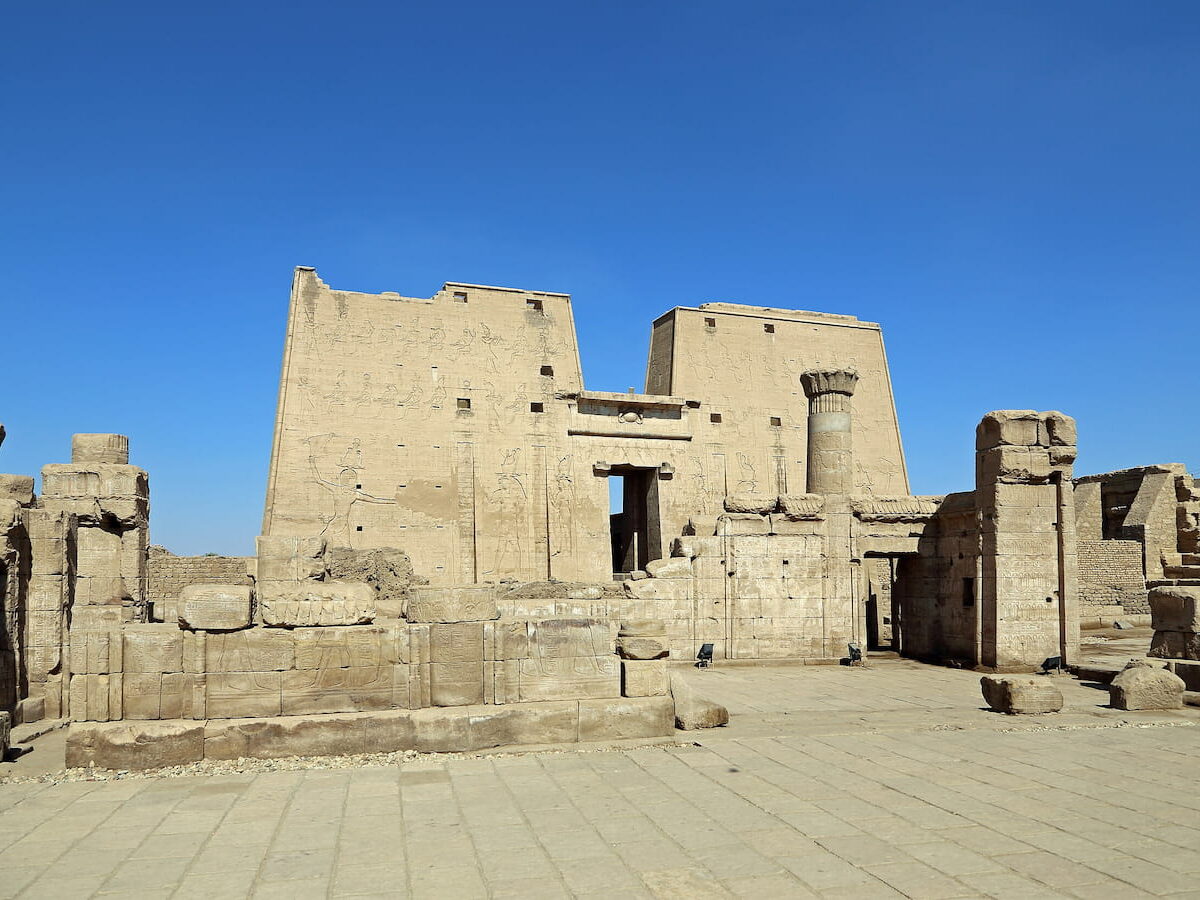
[0,0,1200,553]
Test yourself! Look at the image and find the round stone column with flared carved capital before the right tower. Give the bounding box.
[800,368,858,494]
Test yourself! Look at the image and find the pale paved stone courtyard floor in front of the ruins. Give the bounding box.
[0,660,1200,900]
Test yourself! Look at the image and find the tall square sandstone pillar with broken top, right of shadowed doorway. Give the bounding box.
[976,409,1079,671]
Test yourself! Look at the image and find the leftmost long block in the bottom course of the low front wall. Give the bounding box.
[66,721,204,770]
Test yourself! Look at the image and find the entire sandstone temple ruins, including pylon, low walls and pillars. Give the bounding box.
[0,268,1200,768]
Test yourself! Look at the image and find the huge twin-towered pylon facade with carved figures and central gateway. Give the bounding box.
[263,269,907,584]
